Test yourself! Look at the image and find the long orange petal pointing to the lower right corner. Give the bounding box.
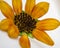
[32,29,54,46]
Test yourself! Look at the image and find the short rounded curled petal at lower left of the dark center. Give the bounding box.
[8,25,19,38]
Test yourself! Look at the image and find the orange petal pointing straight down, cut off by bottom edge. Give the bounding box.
[19,34,30,48]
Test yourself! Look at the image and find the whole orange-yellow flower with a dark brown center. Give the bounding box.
[0,0,59,48]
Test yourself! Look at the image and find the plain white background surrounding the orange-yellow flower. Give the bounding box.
[0,0,60,48]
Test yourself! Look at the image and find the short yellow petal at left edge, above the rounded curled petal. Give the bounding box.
[0,19,11,31]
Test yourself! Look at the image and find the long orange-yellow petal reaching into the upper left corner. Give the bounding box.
[0,1,14,18]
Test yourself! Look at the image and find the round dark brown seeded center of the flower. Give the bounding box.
[14,12,36,33]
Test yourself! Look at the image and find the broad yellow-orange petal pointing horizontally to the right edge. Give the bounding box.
[36,18,59,30]
